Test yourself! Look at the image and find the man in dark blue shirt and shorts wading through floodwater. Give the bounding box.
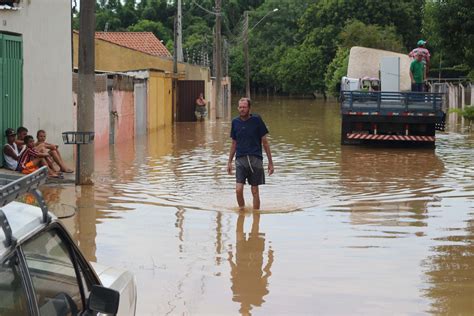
[227,98,273,210]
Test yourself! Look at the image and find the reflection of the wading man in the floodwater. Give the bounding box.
[228,212,274,315]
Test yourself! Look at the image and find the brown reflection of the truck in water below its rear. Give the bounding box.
[333,146,450,232]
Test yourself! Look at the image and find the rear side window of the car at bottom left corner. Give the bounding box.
[0,256,29,316]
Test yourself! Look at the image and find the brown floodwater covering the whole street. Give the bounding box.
[44,98,474,315]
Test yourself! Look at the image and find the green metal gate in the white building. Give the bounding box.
[0,33,23,164]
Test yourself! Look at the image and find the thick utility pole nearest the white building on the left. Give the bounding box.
[76,0,95,184]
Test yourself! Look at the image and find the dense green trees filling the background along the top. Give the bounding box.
[73,0,474,94]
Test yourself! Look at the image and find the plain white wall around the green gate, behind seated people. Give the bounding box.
[0,0,75,158]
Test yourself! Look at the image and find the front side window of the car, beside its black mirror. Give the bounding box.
[23,230,85,316]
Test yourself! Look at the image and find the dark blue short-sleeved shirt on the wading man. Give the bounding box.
[230,114,268,159]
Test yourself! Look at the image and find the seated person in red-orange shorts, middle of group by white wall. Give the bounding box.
[16,135,60,178]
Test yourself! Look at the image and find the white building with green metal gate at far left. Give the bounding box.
[0,0,74,163]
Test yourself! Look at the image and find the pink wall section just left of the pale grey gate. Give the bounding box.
[112,90,135,144]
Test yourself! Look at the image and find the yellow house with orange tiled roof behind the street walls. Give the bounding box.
[73,32,211,131]
